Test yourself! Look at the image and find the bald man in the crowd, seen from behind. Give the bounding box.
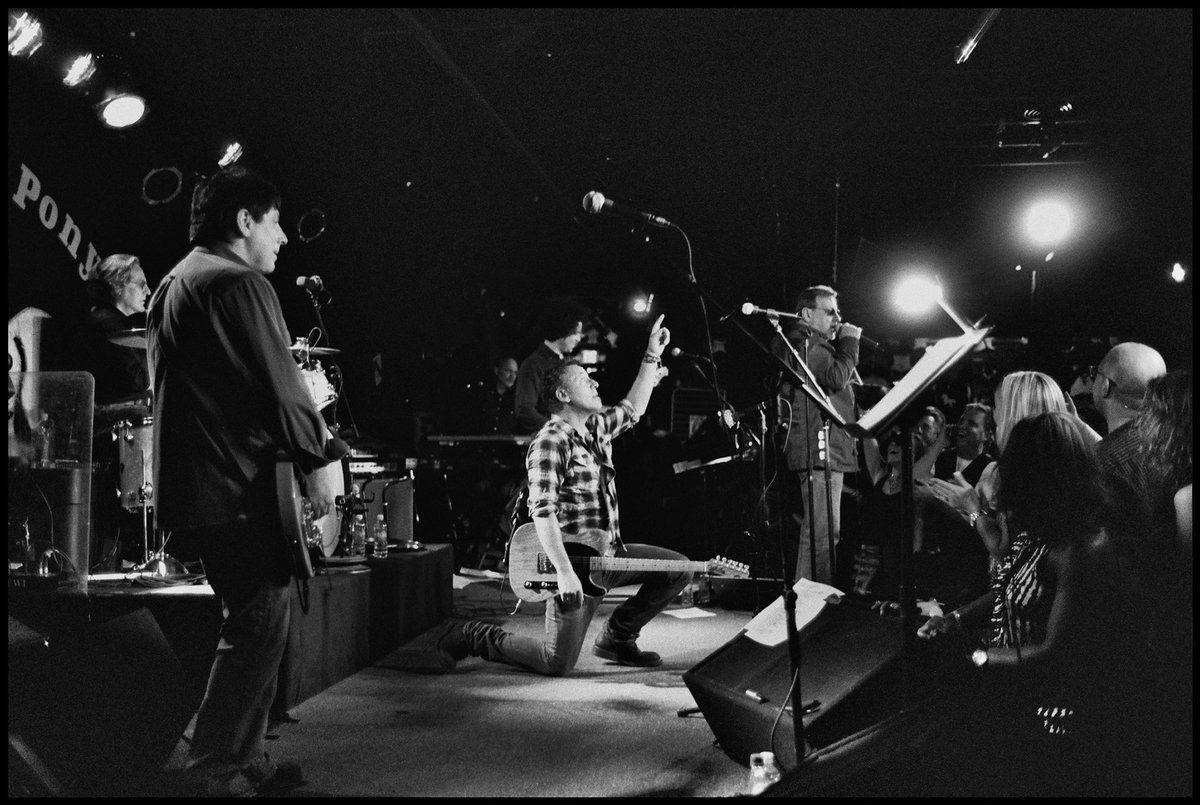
[1092,341,1166,528]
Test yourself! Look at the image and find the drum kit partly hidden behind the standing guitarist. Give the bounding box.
[94,329,341,576]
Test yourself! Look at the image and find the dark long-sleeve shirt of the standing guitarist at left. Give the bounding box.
[146,247,330,529]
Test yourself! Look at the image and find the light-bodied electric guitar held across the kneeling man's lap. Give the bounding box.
[508,523,750,601]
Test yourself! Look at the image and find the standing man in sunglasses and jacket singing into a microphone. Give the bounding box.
[768,286,862,584]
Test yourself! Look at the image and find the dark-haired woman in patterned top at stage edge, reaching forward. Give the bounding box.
[918,411,1133,795]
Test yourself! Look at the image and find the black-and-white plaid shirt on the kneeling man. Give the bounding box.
[526,400,637,554]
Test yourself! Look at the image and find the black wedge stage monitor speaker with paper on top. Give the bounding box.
[683,602,902,768]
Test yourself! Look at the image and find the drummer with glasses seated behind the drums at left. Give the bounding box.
[83,254,150,407]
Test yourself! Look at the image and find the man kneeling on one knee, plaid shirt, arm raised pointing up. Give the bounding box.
[437,316,724,677]
